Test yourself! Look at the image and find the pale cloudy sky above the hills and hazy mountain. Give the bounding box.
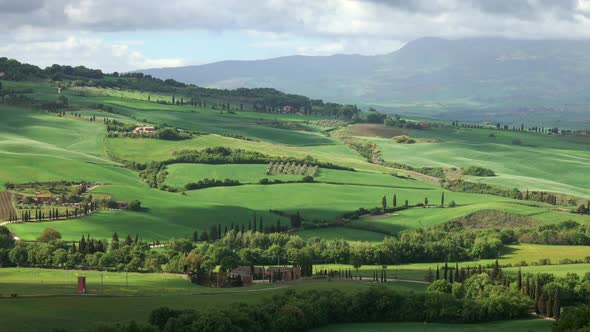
[0,0,590,72]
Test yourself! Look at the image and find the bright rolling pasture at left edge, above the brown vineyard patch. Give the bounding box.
[0,106,143,186]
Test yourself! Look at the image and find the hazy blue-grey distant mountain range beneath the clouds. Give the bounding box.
[141,38,590,127]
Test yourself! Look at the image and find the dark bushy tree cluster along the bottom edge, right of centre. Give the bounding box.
[82,274,530,332]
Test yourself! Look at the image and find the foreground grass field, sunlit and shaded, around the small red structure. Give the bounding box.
[0,269,425,332]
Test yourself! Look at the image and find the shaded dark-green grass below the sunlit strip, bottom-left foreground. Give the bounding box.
[0,278,425,332]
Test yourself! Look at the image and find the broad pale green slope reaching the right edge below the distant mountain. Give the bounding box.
[372,129,590,197]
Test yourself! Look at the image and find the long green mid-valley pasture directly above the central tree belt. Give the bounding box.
[5,183,472,241]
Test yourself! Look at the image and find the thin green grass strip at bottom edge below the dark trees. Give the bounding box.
[313,319,552,332]
